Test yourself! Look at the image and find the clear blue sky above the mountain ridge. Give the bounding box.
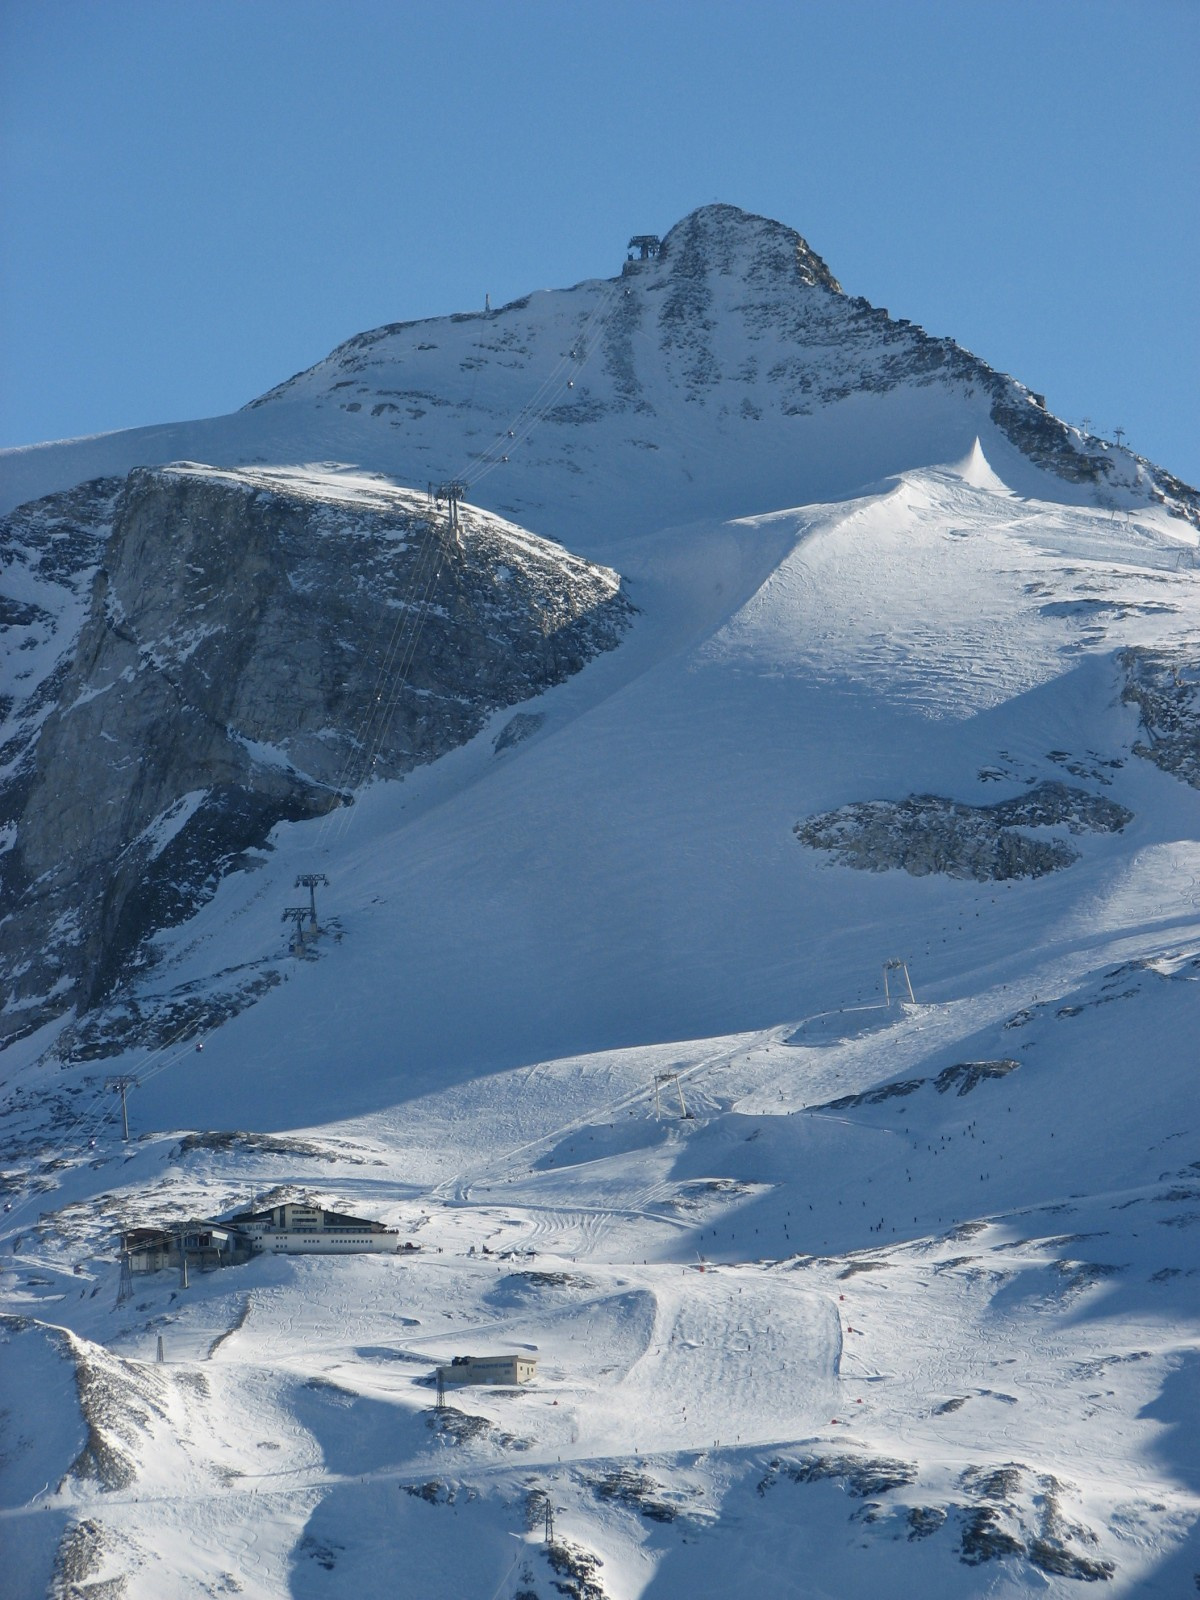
[0,0,1200,483]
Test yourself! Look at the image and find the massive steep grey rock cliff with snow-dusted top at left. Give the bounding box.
[0,464,632,1037]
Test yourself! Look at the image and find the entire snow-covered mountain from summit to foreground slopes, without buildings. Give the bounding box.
[0,206,1200,1600]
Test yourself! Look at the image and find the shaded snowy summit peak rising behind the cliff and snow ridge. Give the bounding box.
[0,205,1200,540]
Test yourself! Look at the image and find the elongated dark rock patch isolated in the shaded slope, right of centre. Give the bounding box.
[794,782,1133,883]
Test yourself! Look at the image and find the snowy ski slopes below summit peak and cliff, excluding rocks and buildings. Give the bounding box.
[0,451,1200,1600]
